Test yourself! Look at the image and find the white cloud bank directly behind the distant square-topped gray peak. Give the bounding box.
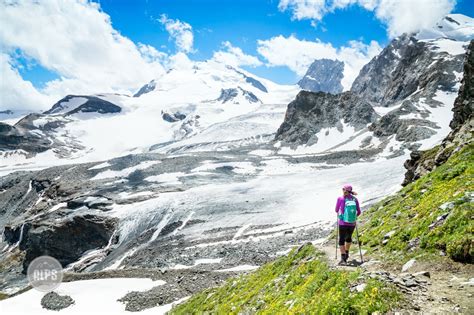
[257,35,382,90]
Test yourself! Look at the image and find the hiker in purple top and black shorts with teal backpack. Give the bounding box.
[336,185,360,264]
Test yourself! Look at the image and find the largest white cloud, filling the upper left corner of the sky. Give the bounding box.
[0,0,164,109]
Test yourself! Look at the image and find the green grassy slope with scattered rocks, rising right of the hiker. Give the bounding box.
[360,144,474,263]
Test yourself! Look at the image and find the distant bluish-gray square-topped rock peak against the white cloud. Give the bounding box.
[298,59,344,94]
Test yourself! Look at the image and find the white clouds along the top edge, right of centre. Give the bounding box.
[278,0,456,37]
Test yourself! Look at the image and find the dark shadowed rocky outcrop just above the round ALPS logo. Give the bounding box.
[16,214,117,271]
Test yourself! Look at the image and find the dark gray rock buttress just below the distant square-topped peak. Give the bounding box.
[275,91,377,144]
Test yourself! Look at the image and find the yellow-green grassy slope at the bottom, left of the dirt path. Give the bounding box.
[170,244,401,314]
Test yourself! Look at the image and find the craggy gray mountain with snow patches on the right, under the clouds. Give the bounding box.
[276,15,474,156]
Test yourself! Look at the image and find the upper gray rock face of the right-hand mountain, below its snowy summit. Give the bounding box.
[351,34,463,106]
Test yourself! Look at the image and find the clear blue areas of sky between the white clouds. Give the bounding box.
[18,0,474,87]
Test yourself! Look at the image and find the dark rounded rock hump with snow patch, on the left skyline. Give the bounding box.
[44,95,122,116]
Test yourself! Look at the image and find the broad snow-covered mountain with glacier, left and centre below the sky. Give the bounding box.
[0,61,299,175]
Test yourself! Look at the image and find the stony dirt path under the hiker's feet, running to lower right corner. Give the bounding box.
[315,240,474,314]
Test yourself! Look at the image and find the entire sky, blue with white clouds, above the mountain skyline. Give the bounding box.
[0,0,474,108]
